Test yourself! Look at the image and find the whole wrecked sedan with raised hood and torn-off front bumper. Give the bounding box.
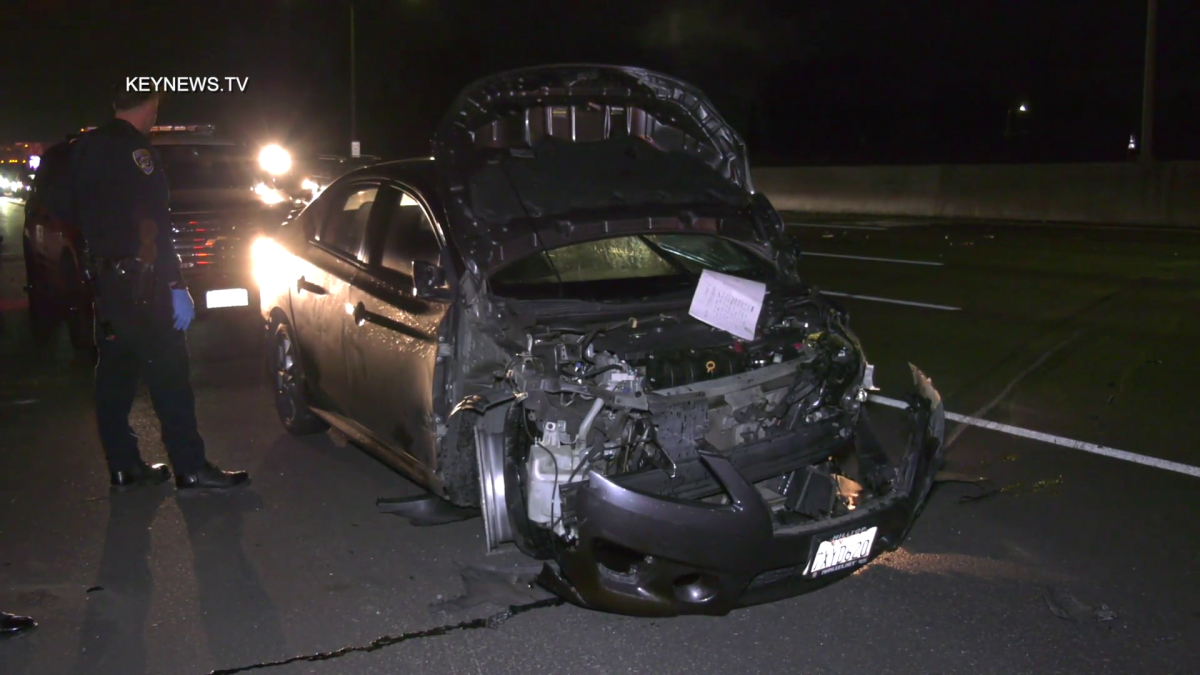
[254,66,944,616]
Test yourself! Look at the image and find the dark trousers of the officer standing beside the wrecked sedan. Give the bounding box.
[96,267,205,474]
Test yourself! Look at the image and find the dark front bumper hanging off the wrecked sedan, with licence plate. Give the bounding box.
[539,368,946,616]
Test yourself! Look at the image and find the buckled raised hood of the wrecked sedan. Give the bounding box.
[433,65,761,273]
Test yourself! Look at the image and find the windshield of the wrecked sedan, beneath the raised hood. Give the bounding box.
[491,234,775,301]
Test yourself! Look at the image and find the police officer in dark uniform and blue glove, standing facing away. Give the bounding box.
[56,91,250,491]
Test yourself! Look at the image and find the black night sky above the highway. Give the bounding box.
[0,0,1200,163]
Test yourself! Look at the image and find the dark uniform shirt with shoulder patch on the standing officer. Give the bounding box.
[72,118,184,288]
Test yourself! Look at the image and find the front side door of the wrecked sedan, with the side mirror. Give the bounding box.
[346,181,450,467]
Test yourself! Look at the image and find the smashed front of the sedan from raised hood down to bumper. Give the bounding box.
[436,66,943,615]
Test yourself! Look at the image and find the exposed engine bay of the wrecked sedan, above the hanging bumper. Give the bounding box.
[484,295,888,550]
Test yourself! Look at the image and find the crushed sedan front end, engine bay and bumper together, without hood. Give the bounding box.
[452,269,944,615]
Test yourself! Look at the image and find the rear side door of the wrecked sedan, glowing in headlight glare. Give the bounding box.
[290,176,380,414]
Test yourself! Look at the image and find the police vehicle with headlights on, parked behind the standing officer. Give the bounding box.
[24,125,295,348]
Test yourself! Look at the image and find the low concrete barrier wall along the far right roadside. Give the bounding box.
[752,162,1200,227]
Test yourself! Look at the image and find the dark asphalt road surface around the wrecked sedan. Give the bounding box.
[0,195,1200,675]
